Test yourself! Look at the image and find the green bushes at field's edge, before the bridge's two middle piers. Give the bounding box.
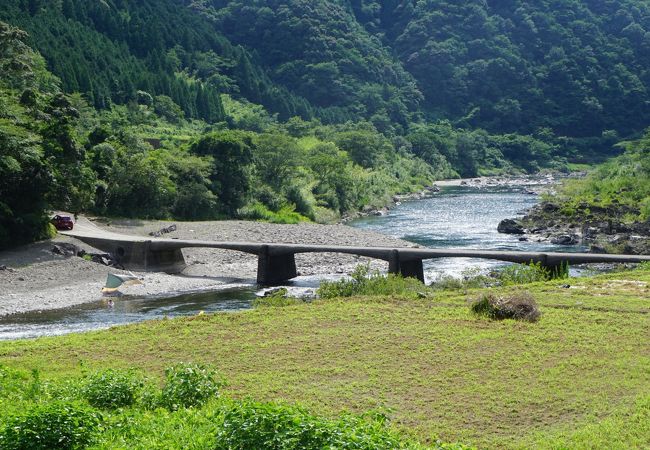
[316,265,426,299]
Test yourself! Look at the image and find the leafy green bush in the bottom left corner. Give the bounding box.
[0,402,100,450]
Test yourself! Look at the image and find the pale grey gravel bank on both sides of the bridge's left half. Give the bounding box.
[0,219,412,315]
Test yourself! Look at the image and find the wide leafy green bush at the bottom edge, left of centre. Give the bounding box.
[216,401,406,450]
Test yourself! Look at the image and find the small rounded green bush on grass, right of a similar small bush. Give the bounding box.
[160,363,224,411]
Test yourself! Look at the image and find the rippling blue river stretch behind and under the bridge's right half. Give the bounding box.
[352,186,581,282]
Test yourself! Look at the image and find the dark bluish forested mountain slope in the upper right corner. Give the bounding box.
[350,0,650,144]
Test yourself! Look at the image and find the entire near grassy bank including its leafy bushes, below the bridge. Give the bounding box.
[0,264,650,449]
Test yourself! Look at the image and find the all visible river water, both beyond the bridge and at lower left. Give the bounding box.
[0,182,575,339]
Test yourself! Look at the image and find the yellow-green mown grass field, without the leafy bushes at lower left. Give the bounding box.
[0,270,650,449]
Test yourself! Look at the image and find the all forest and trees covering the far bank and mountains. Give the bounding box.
[0,0,650,247]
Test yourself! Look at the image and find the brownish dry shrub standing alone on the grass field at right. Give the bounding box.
[471,292,541,322]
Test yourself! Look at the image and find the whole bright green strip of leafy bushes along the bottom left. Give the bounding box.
[0,364,467,450]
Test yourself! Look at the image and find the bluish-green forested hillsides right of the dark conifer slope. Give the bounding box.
[192,0,650,151]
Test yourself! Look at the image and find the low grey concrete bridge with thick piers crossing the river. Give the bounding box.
[62,226,650,285]
